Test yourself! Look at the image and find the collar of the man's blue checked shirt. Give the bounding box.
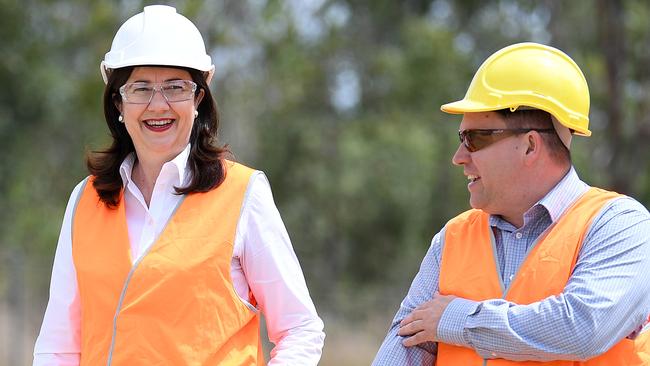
[489,166,589,227]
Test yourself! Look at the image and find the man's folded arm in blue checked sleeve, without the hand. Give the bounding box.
[438,198,650,361]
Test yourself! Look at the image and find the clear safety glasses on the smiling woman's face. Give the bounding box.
[120,80,196,104]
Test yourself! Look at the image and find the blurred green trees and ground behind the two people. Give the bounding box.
[0,0,650,366]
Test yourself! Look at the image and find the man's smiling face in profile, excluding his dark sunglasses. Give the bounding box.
[452,112,526,222]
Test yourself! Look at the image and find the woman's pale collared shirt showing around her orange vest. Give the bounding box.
[34,145,325,366]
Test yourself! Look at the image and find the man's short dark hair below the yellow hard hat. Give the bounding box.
[496,108,571,163]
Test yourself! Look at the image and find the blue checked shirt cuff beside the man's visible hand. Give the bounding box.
[437,297,480,347]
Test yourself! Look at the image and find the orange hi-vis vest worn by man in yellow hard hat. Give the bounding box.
[436,188,650,366]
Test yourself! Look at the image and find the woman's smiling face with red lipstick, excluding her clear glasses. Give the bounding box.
[117,66,204,162]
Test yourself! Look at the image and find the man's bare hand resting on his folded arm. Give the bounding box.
[397,293,456,347]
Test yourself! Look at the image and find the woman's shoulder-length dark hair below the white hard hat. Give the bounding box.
[86,66,229,208]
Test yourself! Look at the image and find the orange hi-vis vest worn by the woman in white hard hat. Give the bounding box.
[72,161,264,366]
